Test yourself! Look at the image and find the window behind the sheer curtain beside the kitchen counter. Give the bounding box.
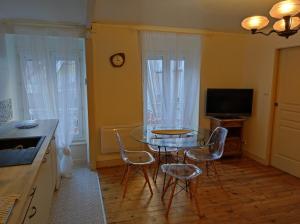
[22,55,85,141]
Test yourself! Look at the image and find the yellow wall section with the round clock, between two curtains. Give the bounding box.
[87,24,143,166]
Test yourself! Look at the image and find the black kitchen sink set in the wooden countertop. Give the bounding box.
[0,136,45,167]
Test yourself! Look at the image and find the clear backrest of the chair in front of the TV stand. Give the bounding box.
[208,127,228,158]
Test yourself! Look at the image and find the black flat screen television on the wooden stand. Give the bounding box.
[206,88,253,118]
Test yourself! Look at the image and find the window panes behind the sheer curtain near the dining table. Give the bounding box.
[145,59,189,126]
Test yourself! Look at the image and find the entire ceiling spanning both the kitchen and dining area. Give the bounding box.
[0,0,278,32]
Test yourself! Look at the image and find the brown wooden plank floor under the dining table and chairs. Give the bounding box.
[98,158,300,224]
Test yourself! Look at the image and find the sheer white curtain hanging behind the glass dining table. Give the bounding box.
[141,32,201,129]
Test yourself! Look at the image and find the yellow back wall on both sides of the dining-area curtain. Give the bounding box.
[87,23,251,166]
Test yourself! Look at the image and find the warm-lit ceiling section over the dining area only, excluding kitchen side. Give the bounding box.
[93,0,278,32]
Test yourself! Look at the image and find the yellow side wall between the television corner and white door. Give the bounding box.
[242,34,300,164]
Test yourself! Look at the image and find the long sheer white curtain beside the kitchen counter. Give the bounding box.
[13,34,81,177]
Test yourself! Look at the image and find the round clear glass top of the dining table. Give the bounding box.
[130,126,210,149]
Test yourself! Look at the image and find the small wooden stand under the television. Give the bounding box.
[209,117,246,157]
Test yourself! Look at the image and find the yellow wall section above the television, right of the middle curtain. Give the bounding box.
[200,34,245,128]
